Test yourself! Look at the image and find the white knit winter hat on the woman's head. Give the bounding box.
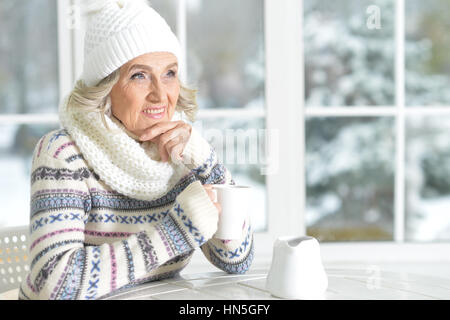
[81,0,183,86]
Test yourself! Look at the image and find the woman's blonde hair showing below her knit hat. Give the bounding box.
[67,69,198,130]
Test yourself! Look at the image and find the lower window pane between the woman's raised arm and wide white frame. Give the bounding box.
[194,119,267,231]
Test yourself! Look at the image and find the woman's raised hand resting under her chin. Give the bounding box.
[140,121,192,162]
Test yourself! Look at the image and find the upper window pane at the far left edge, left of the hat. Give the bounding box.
[0,0,59,114]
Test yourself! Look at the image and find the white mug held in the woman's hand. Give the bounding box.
[212,184,252,240]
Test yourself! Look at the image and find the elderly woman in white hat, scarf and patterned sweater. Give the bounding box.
[19,0,253,299]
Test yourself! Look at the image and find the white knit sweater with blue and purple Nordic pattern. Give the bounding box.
[19,128,254,299]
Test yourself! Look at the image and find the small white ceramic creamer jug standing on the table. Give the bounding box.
[266,236,328,299]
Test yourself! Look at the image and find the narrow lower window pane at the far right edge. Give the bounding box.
[406,116,450,241]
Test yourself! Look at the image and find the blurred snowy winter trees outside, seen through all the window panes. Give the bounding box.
[0,0,450,241]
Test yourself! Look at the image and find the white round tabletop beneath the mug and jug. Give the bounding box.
[0,265,450,300]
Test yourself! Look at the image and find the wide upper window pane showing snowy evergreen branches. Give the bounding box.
[303,0,395,106]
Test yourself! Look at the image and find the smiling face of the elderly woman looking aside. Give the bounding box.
[110,52,180,137]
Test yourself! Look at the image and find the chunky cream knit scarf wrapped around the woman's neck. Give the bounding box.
[59,94,189,201]
